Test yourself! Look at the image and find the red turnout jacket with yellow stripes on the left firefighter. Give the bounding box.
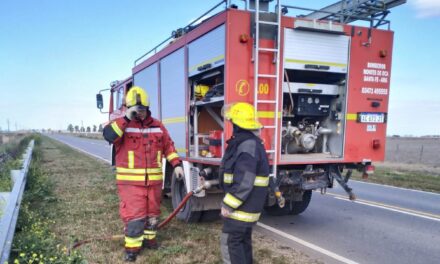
[103,117,180,185]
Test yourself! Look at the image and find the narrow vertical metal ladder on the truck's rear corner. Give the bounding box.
[254,0,281,178]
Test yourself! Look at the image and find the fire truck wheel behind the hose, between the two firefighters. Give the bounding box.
[171,171,201,223]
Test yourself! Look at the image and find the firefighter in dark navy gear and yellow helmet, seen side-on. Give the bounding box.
[220,102,269,264]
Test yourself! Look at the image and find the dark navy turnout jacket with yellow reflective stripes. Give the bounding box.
[220,130,269,225]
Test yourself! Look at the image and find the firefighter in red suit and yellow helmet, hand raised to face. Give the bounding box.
[103,86,183,262]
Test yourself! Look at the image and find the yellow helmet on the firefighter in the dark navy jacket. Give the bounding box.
[224,102,263,130]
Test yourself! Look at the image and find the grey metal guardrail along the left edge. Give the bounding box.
[0,140,34,263]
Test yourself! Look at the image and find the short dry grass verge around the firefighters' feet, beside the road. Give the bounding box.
[8,137,317,264]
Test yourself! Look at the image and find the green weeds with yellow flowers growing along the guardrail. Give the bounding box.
[10,137,82,264]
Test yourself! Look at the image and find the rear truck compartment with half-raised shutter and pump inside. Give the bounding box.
[281,29,349,162]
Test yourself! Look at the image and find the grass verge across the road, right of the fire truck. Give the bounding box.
[352,164,440,193]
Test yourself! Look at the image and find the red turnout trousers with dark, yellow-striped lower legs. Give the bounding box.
[118,184,162,252]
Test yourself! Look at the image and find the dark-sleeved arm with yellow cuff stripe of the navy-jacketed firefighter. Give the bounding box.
[222,152,257,211]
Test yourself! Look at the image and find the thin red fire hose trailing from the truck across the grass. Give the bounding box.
[68,180,218,252]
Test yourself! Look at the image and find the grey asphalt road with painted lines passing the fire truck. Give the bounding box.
[46,134,440,264]
